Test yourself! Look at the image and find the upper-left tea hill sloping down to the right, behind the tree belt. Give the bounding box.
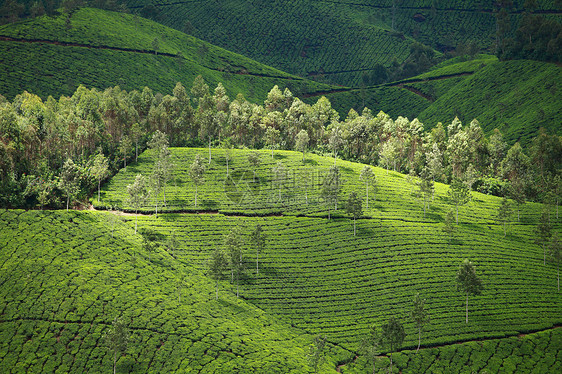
[0,8,329,101]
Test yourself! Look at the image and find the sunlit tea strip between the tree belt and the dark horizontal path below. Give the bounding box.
[91,148,541,224]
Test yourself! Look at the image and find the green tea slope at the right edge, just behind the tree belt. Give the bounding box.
[419,60,562,144]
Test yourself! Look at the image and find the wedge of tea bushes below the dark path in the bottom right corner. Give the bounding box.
[341,328,562,373]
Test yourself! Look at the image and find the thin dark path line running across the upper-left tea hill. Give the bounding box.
[0,35,304,80]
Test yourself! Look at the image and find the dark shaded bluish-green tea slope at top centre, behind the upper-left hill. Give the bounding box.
[127,0,413,86]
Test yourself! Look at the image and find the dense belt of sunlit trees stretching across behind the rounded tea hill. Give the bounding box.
[0,76,562,207]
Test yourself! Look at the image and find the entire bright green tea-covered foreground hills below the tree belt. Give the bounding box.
[0,148,562,373]
